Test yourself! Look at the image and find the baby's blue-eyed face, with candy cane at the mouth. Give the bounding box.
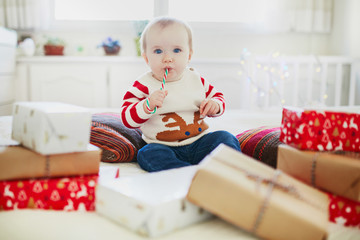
[143,23,192,82]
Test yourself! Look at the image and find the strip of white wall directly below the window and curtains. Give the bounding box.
[20,25,332,58]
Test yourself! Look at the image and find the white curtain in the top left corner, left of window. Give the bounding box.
[0,0,52,30]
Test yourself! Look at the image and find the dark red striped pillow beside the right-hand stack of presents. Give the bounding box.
[236,127,283,168]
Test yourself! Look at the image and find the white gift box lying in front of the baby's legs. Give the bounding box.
[96,166,212,237]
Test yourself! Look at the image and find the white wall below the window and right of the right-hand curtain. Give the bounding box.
[15,0,360,58]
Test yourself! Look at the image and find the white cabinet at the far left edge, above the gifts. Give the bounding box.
[0,27,17,116]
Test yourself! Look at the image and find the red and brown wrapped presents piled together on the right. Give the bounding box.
[187,107,360,239]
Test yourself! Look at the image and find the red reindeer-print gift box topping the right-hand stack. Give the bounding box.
[280,107,360,152]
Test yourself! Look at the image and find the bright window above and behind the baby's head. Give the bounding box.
[54,0,266,22]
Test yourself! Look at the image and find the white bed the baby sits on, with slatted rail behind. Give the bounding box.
[0,53,360,240]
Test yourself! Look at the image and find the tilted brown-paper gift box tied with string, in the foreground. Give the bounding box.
[187,145,329,240]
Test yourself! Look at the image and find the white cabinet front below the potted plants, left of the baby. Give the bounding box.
[28,63,108,107]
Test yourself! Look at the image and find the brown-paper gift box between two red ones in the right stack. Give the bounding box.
[277,144,360,201]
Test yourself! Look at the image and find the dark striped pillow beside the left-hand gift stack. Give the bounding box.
[90,113,146,162]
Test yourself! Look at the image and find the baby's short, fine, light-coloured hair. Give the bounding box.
[140,17,193,53]
